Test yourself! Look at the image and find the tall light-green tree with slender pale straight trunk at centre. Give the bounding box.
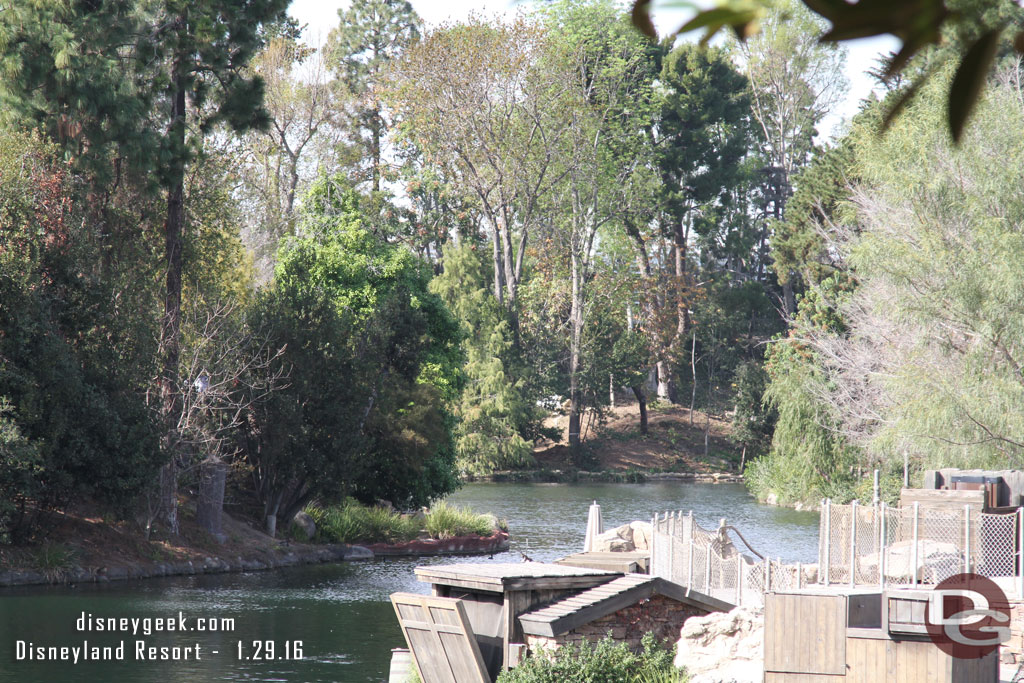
[546,2,656,449]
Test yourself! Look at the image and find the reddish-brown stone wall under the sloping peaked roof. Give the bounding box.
[526,595,708,652]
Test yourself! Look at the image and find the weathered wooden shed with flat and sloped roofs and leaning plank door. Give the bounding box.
[403,562,732,683]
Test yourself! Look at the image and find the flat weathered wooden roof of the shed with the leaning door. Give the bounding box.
[416,562,622,593]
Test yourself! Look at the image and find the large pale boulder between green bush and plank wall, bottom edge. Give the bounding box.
[675,607,764,683]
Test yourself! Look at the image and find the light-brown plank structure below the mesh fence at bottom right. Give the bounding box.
[764,589,998,683]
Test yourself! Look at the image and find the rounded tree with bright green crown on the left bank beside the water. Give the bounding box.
[245,179,462,532]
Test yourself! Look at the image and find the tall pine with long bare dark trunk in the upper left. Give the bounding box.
[0,0,287,532]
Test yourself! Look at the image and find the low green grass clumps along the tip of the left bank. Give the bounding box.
[305,500,505,544]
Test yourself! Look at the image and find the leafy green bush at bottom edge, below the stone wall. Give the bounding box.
[498,633,686,683]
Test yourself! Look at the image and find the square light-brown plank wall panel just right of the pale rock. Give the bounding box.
[765,593,846,681]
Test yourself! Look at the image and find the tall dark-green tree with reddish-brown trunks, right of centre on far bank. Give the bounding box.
[630,44,753,400]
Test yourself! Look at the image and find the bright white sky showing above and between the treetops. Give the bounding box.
[288,0,899,136]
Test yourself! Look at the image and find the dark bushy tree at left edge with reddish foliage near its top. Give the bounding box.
[0,131,161,541]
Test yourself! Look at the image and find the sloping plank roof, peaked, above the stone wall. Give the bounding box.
[519,573,732,637]
